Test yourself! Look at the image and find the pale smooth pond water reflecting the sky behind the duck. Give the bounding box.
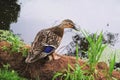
[11,0,120,49]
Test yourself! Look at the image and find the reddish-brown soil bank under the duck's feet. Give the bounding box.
[0,42,120,80]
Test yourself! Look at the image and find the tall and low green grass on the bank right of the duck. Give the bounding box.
[52,31,115,80]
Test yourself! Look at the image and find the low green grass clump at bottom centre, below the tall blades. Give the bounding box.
[52,64,94,80]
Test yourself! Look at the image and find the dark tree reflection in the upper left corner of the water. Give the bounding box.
[0,0,20,30]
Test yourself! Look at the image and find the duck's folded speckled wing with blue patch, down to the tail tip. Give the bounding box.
[26,30,60,63]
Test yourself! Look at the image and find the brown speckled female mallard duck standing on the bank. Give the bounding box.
[25,19,76,63]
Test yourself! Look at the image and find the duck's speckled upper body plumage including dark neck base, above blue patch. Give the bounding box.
[31,27,63,52]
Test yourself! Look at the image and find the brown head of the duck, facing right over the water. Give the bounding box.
[60,19,77,30]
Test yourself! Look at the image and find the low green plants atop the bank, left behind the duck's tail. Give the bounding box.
[0,30,28,56]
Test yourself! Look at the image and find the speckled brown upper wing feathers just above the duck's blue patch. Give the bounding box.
[32,30,61,51]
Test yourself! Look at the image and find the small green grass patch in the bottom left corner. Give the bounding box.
[0,64,26,80]
